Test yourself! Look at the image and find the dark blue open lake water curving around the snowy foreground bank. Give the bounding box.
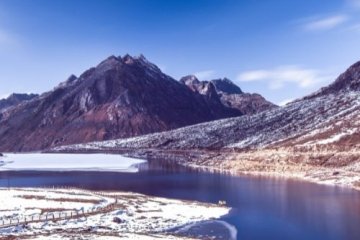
[0,160,360,240]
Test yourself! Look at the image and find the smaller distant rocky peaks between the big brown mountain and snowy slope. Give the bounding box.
[180,75,277,115]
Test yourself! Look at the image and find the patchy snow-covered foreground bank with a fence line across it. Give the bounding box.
[0,188,229,239]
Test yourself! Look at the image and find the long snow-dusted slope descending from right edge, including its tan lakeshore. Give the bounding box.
[53,62,360,190]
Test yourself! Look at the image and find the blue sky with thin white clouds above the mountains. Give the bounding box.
[0,0,360,104]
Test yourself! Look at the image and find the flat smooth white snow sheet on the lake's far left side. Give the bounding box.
[0,153,146,172]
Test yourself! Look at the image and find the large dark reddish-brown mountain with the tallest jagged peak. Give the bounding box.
[0,55,241,151]
